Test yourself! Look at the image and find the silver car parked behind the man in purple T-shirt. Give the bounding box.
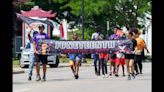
[19,47,59,68]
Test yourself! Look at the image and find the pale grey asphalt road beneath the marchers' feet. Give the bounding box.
[13,63,152,92]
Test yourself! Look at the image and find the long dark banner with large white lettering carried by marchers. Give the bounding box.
[38,40,133,55]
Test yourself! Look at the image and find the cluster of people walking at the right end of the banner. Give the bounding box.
[91,27,149,80]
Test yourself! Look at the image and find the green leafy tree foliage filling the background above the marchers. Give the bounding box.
[13,0,151,38]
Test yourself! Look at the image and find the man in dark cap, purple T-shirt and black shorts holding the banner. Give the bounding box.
[33,25,49,81]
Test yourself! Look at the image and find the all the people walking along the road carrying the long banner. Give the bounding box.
[28,25,149,81]
